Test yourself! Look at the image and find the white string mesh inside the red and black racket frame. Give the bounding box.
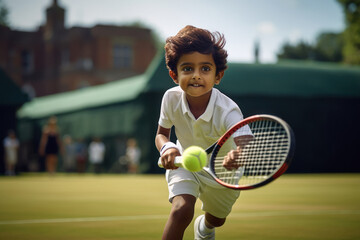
[214,120,289,185]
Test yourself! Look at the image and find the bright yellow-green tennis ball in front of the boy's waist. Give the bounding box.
[182,146,207,172]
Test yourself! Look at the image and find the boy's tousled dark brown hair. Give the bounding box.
[165,25,228,74]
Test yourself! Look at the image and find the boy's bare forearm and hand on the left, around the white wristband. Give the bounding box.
[155,125,180,169]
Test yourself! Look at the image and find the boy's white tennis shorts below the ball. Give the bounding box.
[166,168,240,218]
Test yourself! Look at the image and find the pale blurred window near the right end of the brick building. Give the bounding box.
[113,45,133,68]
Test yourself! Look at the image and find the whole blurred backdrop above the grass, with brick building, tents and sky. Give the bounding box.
[0,0,360,175]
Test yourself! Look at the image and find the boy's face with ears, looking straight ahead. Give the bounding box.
[170,52,224,97]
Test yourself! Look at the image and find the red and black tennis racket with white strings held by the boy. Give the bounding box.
[158,114,295,190]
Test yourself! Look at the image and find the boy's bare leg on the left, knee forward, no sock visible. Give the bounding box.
[162,194,196,240]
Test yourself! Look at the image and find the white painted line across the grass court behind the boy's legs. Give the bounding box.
[0,210,360,225]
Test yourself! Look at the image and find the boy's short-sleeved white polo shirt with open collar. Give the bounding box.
[159,86,246,152]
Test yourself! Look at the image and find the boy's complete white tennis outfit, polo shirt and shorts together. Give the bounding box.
[159,86,251,218]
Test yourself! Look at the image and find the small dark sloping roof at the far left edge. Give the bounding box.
[0,68,29,106]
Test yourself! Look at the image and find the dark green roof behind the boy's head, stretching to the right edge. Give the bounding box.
[146,55,360,97]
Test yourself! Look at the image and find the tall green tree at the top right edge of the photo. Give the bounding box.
[338,0,360,65]
